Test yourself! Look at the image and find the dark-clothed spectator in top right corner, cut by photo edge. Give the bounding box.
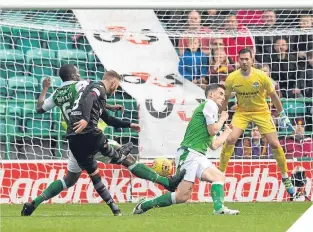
[290,15,313,60]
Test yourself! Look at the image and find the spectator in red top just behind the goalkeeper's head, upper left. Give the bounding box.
[223,15,255,62]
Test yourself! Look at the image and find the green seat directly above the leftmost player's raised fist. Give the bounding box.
[26,48,56,79]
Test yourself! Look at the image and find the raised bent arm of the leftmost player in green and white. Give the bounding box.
[36,77,55,114]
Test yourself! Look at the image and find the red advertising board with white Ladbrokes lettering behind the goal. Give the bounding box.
[0,161,313,203]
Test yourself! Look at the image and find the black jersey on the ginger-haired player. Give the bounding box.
[67,82,107,136]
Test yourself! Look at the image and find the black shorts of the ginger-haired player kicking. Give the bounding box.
[67,133,108,174]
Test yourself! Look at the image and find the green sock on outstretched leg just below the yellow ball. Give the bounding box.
[128,163,169,188]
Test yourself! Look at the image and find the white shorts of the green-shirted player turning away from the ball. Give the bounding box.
[175,148,214,183]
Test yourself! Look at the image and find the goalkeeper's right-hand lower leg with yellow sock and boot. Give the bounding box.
[264,132,295,197]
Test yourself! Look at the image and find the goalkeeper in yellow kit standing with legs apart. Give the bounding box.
[219,49,295,199]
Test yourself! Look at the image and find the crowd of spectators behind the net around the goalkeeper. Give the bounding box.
[157,10,313,158]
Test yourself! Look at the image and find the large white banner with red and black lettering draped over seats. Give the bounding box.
[74,10,219,158]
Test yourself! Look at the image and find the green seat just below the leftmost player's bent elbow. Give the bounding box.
[24,103,53,137]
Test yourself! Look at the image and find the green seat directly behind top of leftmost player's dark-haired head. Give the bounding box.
[58,49,88,76]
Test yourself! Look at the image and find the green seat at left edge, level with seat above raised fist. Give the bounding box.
[0,49,25,79]
